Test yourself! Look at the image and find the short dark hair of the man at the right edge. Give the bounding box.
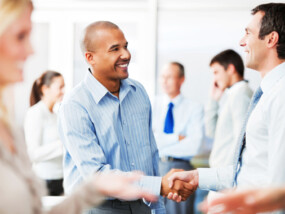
[251,3,285,59]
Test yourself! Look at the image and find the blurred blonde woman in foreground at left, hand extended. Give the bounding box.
[0,0,154,214]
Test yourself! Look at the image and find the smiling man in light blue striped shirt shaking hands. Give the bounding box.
[59,21,192,214]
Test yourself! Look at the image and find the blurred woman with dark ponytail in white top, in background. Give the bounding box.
[24,71,64,196]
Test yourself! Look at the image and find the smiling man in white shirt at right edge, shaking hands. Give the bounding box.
[169,3,285,212]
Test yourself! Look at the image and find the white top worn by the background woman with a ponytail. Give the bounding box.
[24,101,63,180]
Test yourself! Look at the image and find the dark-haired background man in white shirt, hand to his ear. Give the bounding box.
[205,50,252,167]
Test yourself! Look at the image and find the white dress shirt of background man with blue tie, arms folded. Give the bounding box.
[153,94,204,160]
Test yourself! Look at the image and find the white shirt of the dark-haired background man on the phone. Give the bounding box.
[205,81,252,167]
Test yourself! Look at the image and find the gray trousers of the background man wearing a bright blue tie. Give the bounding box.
[159,160,195,214]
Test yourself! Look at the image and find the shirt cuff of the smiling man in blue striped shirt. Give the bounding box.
[139,176,162,196]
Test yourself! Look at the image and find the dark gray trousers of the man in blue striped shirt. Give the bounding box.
[85,200,151,214]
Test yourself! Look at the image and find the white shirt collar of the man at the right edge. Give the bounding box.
[260,62,285,93]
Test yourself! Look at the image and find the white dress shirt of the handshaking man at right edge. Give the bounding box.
[198,63,285,190]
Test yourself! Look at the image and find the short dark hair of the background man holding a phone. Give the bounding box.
[210,49,244,77]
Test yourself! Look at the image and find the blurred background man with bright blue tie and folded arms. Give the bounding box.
[153,62,203,214]
